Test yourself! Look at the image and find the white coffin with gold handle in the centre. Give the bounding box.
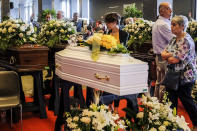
[55,47,148,96]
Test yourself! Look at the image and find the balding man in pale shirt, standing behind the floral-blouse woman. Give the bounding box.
[152,2,173,99]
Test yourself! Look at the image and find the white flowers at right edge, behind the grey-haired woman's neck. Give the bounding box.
[187,21,197,42]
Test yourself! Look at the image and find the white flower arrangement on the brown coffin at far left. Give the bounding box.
[0,19,36,50]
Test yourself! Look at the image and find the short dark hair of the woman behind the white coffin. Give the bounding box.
[105,12,120,25]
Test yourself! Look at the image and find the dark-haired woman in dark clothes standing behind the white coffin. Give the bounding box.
[100,12,138,117]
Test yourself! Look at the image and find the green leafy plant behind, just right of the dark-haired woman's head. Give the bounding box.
[123,3,142,18]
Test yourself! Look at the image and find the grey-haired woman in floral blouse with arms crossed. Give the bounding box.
[161,16,197,131]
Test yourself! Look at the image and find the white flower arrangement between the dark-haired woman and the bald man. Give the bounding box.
[123,19,153,50]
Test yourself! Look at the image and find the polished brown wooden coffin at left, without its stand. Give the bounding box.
[0,44,49,70]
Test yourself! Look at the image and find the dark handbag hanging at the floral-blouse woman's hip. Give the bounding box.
[162,68,182,91]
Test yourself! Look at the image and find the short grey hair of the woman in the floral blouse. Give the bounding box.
[172,15,188,31]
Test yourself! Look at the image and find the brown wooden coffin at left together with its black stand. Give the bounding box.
[0,44,49,118]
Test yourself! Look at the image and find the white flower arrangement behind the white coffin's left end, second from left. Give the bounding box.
[38,20,76,48]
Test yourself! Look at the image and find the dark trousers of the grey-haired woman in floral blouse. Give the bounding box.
[166,82,197,126]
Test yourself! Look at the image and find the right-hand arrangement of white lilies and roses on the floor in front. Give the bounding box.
[124,95,190,131]
